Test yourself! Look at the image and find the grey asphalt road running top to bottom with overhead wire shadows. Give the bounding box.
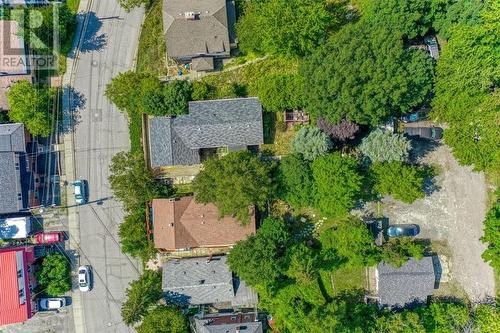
[69,0,144,333]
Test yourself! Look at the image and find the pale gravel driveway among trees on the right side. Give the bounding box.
[374,143,495,302]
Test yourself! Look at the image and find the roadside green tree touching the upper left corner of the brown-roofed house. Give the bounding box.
[109,152,173,211]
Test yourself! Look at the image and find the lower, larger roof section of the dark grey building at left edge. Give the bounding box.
[0,152,24,214]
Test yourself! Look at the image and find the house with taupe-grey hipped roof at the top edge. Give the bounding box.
[163,0,236,71]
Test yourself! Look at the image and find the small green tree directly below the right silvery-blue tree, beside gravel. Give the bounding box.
[371,161,425,203]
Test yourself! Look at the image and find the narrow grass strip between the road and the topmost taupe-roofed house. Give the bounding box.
[137,0,167,75]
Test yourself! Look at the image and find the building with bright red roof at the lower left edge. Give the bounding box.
[0,246,36,326]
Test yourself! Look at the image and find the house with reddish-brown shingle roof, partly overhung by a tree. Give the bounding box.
[149,196,255,251]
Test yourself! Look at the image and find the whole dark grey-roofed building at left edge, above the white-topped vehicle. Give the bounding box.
[0,124,27,214]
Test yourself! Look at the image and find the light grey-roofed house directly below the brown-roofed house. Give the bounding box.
[162,256,258,308]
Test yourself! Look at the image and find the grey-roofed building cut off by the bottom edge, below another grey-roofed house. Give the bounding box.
[190,313,263,333]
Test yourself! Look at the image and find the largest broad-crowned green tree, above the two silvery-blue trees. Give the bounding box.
[301,1,433,125]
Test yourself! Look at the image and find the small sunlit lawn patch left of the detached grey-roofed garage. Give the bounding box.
[320,267,366,297]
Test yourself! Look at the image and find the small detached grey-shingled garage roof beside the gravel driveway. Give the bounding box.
[378,257,437,307]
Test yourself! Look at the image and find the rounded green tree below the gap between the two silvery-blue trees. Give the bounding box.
[311,153,363,216]
